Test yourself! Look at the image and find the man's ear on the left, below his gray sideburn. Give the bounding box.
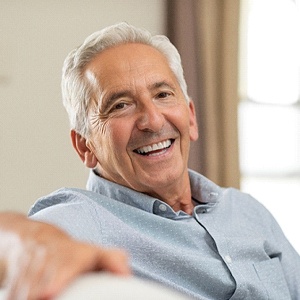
[71,130,98,169]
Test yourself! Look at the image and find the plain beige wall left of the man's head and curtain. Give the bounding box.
[0,0,164,212]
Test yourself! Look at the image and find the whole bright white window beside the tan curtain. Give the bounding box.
[239,0,300,253]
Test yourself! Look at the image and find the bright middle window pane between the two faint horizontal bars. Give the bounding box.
[239,102,300,176]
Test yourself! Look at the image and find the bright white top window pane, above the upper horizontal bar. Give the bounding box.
[246,0,300,105]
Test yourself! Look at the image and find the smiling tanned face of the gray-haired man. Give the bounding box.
[86,44,198,195]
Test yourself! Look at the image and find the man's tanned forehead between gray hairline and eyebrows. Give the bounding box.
[86,43,177,89]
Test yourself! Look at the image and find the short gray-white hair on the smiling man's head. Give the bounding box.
[61,23,189,137]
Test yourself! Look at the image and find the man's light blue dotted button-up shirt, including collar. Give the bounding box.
[29,170,300,300]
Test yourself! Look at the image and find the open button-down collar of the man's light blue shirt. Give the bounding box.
[86,170,222,219]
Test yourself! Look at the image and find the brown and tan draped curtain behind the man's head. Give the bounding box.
[166,0,240,188]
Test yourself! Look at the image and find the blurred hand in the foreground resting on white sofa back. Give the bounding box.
[0,213,130,299]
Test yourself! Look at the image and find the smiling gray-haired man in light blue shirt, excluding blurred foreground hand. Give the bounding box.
[0,23,300,299]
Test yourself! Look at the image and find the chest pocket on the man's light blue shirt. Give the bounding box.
[253,257,291,300]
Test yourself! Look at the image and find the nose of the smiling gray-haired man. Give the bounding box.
[136,100,164,132]
